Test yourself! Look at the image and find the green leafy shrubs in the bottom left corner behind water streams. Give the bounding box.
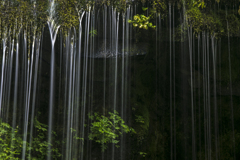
[0,118,61,160]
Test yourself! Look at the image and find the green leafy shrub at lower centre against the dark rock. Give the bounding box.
[88,111,135,152]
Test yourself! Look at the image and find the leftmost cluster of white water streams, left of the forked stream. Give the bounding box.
[0,22,43,159]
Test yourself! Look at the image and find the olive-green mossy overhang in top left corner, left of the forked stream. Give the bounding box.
[0,0,47,33]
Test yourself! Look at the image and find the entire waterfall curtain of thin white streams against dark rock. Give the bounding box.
[0,1,240,160]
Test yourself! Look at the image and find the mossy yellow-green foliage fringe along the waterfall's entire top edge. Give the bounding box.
[0,0,240,40]
